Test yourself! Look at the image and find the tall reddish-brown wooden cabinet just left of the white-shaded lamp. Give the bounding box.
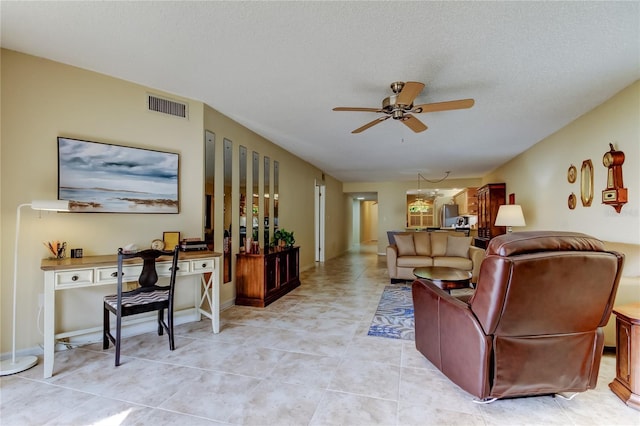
[475,183,507,248]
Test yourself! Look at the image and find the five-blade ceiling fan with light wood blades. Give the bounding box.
[333,81,475,133]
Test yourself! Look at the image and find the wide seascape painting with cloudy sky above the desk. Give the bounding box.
[58,137,179,213]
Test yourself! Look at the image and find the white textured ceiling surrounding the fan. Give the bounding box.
[0,1,640,182]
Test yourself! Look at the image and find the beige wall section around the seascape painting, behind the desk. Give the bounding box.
[1,50,203,352]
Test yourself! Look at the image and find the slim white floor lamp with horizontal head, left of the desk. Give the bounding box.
[0,200,69,376]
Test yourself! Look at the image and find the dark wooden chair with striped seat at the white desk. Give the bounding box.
[102,246,179,367]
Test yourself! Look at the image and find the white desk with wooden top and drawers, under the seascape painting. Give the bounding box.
[40,251,221,379]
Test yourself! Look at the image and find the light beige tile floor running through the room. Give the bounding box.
[0,245,640,426]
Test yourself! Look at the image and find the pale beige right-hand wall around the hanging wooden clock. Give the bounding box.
[483,81,640,248]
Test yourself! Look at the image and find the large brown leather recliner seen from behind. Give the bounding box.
[413,231,624,400]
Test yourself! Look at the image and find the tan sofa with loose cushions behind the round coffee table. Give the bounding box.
[386,231,484,283]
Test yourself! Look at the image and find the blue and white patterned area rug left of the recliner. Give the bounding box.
[368,285,415,340]
